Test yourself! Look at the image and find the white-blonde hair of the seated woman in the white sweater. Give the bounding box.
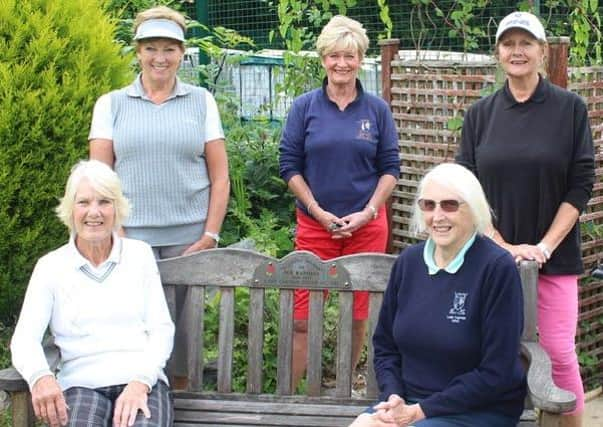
[56,160,130,232]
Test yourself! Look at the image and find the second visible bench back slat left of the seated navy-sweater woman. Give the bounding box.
[335,292,354,397]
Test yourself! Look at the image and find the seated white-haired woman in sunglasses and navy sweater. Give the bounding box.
[352,163,526,427]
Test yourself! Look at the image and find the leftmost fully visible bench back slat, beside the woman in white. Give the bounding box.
[182,286,205,390]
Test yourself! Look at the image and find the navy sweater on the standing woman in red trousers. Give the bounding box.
[280,80,400,217]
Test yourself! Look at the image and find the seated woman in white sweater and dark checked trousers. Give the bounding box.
[11,160,174,426]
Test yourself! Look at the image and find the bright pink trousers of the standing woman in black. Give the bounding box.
[538,274,584,414]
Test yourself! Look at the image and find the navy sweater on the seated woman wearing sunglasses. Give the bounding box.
[373,236,526,417]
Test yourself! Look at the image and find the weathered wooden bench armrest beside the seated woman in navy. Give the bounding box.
[521,342,576,414]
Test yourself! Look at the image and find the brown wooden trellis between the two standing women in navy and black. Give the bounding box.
[391,61,496,252]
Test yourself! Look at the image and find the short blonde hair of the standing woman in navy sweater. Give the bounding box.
[316,15,369,59]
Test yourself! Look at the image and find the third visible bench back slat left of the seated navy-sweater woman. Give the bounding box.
[306,290,324,396]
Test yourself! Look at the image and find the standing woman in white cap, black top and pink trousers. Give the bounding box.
[457,12,594,427]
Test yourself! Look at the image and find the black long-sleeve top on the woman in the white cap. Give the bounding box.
[456,77,594,274]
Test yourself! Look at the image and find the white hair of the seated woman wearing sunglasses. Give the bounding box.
[410,163,492,235]
